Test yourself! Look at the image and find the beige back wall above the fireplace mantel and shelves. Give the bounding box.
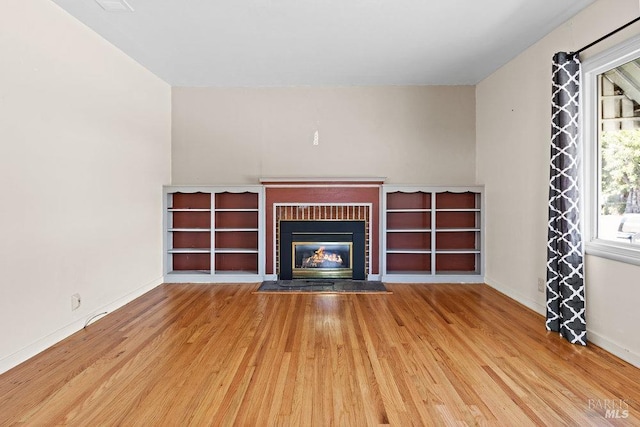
[172,86,475,185]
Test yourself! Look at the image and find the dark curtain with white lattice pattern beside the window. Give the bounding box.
[546,52,587,345]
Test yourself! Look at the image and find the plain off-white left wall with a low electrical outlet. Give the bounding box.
[0,0,171,372]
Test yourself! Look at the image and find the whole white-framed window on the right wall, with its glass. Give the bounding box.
[582,37,640,265]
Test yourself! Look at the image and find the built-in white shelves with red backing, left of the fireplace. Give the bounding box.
[164,186,265,282]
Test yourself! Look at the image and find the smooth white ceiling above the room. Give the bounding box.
[53,0,594,87]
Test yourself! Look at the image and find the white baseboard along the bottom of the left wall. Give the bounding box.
[0,277,163,374]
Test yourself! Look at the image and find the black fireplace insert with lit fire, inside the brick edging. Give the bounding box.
[279,220,365,280]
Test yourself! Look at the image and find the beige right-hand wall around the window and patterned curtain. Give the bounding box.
[476,0,640,365]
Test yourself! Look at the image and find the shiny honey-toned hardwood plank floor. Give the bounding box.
[0,285,640,426]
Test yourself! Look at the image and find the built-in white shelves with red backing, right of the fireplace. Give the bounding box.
[382,185,484,283]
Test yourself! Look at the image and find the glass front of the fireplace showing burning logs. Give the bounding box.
[291,241,353,279]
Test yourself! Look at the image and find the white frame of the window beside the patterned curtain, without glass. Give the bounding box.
[580,35,640,266]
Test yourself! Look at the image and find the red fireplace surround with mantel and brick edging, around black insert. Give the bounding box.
[261,178,384,278]
